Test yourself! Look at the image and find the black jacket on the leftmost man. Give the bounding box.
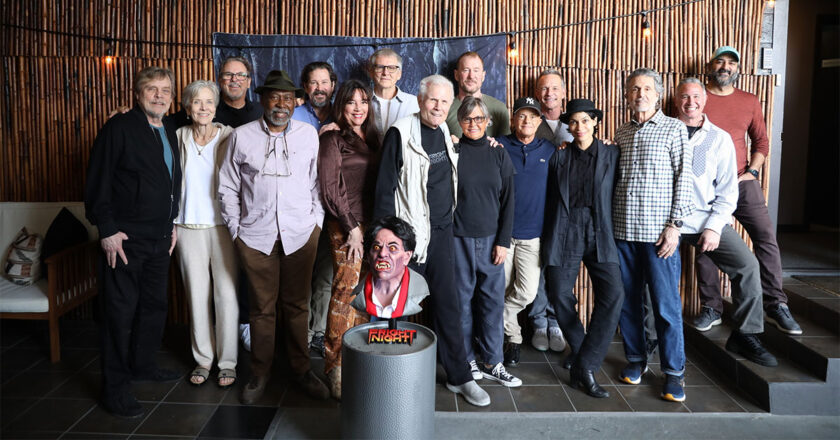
[85,106,181,239]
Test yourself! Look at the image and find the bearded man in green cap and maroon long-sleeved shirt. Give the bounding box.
[693,46,802,335]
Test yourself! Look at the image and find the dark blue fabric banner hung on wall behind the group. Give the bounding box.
[213,33,507,102]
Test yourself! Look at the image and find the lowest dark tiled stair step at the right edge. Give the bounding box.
[684,319,840,415]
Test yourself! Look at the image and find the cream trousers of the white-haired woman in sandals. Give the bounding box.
[175,226,239,369]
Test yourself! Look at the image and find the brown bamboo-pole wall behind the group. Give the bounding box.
[0,0,775,326]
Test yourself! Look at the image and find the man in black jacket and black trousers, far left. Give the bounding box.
[85,67,181,418]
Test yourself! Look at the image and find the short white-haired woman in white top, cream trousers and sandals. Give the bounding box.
[175,80,239,387]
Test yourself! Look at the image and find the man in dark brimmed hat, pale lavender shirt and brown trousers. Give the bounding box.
[219,70,329,404]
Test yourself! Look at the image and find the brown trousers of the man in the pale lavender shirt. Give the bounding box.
[235,226,321,376]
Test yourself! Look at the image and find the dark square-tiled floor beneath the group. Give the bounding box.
[0,320,763,439]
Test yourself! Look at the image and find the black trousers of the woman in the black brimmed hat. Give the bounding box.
[545,208,624,372]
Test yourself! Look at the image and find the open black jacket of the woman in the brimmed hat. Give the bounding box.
[540,139,619,266]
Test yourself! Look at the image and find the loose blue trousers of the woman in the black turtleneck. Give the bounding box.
[454,235,505,365]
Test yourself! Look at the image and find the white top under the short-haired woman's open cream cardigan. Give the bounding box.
[175,130,224,226]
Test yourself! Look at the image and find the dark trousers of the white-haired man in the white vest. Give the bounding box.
[410,223,476,385]
